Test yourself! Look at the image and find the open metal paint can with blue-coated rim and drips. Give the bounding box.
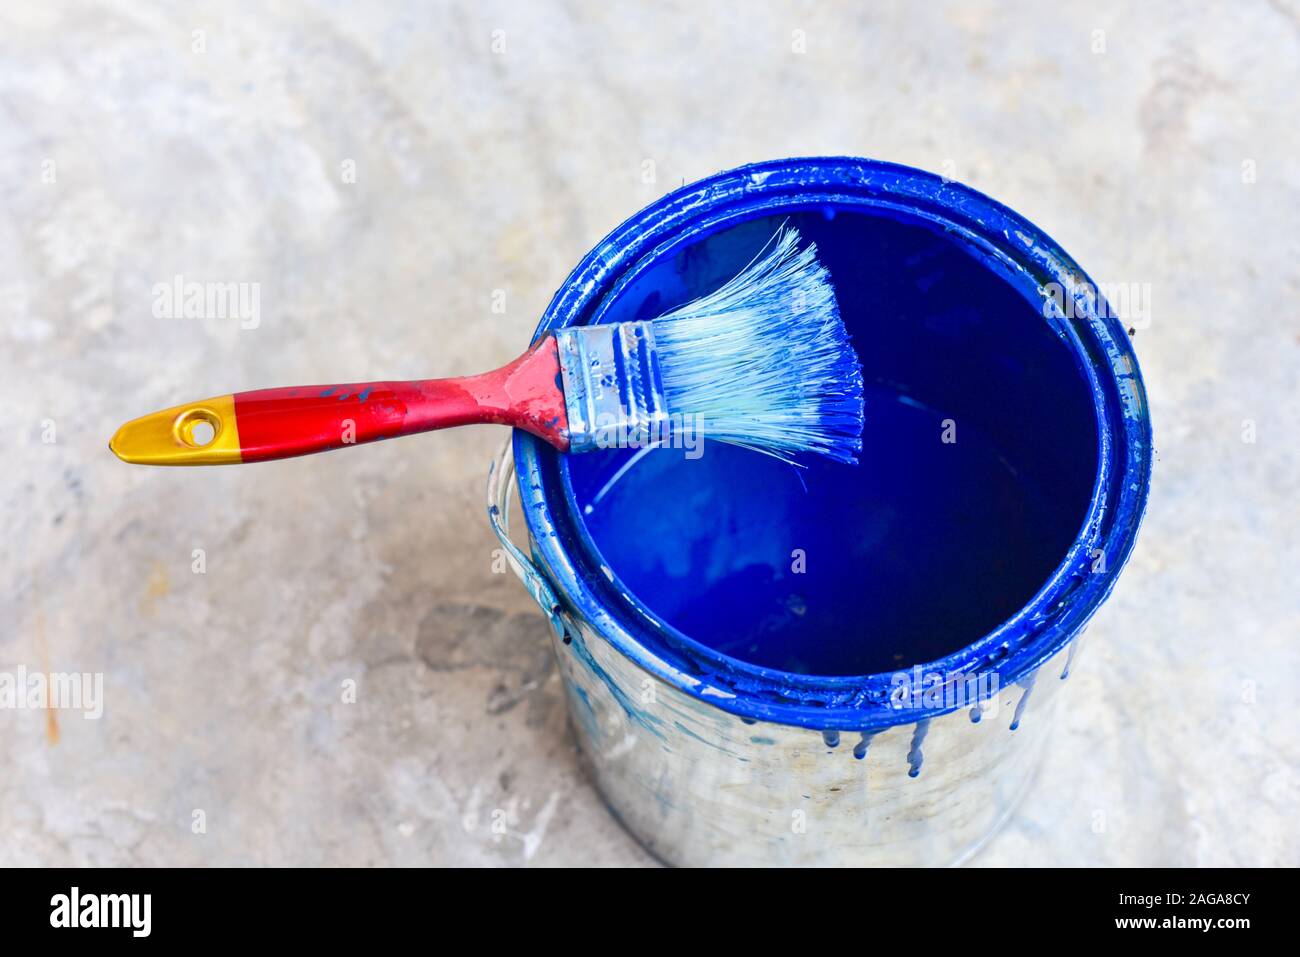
[489,157,1151,866]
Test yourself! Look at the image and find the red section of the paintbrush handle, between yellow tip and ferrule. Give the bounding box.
[234,337,568,462]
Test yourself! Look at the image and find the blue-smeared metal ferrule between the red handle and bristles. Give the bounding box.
[555,321,668,452]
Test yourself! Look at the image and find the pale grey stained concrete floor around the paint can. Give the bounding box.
[0,0,1300,866]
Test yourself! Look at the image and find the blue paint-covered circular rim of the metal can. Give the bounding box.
[514,157,1152,731]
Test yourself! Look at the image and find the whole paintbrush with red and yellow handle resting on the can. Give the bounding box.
[109,228,863,465]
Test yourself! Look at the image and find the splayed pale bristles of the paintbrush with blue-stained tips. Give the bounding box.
[650,228,863,463]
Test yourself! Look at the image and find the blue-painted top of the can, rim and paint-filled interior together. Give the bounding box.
[515,159,1151,732]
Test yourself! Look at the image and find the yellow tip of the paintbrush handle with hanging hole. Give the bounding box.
[108,395,243,465]
